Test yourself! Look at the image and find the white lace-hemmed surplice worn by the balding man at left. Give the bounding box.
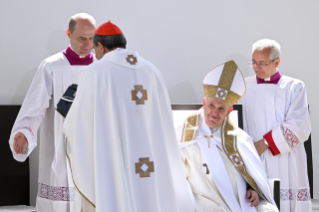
[9,52,91,212]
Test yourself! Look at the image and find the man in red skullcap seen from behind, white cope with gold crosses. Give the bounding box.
[64,22,194,212]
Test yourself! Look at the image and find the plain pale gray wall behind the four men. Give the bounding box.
[0,0,319,205]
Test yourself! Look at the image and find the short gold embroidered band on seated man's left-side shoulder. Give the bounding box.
[181,112,200,142]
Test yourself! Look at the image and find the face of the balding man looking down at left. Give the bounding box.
[69,19,95,56]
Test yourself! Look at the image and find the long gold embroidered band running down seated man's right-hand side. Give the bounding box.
[220,118,269,202]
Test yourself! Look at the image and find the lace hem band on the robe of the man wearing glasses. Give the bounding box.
[280,188,311,201]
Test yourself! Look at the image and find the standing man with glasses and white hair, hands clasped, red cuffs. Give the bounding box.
[240,39,312,212]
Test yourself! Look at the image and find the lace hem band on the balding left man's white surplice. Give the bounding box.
[38,182,76,202]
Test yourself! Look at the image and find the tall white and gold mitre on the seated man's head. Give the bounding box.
[203,60,246,105]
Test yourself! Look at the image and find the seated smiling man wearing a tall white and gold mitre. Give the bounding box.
[177,61,278,212]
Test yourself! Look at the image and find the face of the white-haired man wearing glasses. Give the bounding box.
[252,48,280,79]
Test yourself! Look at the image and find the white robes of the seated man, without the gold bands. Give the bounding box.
[177,109,278,212]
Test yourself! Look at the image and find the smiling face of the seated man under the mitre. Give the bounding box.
[203,98,231,128]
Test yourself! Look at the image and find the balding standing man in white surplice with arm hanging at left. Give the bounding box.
[9,13,96,212]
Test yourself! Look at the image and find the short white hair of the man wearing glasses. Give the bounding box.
[252,39,281,60]
